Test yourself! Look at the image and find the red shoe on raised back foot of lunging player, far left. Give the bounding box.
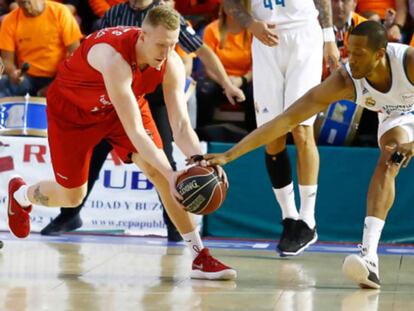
[7,177,32,239]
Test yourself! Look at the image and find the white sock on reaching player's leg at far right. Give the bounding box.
[362,216,385,260]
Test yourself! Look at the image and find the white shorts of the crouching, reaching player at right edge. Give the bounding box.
[377,113,414,146]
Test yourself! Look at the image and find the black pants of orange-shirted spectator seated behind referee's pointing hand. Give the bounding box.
[197,78,256,132]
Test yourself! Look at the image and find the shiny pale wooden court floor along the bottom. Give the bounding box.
[0,233,414,311]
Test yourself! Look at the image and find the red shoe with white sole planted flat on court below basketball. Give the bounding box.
[191,248,237,280]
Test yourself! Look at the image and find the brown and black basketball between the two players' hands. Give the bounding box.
[176,166,227,215]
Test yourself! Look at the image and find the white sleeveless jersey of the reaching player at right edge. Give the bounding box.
[345,43,414,120]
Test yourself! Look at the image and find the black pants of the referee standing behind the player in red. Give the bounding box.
[60,86,176,232]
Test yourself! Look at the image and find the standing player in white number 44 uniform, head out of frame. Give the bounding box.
[224,0,339,256]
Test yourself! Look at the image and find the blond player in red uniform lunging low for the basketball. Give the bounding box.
[8,6,236,279]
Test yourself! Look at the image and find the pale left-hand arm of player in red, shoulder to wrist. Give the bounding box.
[88,43,173,180]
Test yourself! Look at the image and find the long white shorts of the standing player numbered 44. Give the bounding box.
[252,19,323,126]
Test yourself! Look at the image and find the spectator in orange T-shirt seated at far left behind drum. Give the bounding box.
[0,0,82,97]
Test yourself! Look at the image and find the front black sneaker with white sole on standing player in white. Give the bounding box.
[280,219,318,256]
